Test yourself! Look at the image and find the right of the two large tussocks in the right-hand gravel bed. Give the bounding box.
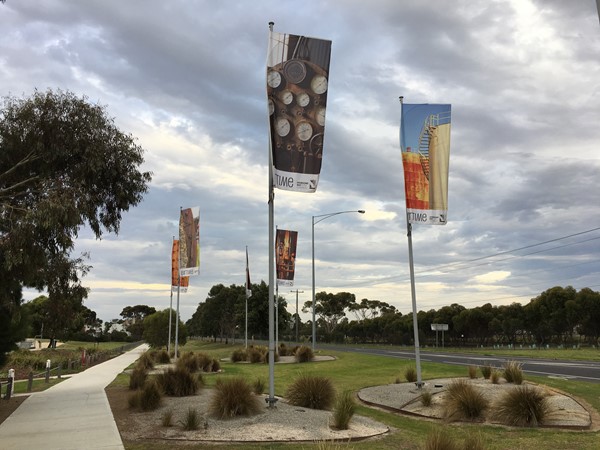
[495,385,549,427]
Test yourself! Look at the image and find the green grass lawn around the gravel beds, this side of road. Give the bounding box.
[119,341,600,450]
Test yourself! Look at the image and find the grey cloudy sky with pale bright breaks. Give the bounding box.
[0,0,600,320]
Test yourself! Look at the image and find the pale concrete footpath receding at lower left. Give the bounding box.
[0,344,148,450]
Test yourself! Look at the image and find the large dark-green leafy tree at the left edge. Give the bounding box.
[0,90,151,358]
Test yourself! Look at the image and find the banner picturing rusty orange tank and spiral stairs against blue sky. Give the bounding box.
[400,104,451,225]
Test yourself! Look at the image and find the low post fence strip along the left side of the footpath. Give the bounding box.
[0,341,144,400]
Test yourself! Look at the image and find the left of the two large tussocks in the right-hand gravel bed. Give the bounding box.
[444,379,489,421]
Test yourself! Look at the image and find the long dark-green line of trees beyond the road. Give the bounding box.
[186,281,600,347]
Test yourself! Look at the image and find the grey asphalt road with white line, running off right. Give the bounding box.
[317,344,600,383]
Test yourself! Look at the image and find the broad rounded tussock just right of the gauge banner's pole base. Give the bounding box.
[286,374,335,409]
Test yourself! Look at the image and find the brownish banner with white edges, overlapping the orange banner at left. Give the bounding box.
[179,206,200,277]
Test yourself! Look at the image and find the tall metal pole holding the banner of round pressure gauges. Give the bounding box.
[265,22,277,408]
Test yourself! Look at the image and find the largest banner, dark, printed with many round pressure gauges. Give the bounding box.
[267,33,331,192]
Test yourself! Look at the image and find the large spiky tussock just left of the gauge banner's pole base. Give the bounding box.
[209,378,261,419]
